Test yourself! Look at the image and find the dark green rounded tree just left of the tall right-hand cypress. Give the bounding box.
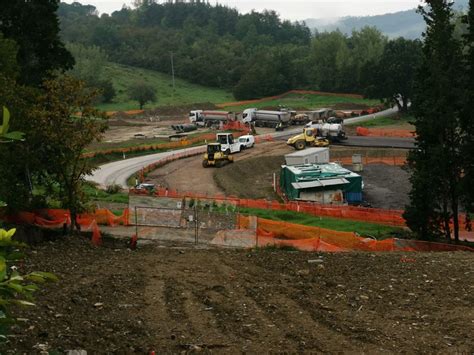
[365,38,422,112]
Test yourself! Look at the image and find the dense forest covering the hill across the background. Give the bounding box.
[58,0,421,105]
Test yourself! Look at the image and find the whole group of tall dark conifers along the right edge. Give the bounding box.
[404,0,474,241]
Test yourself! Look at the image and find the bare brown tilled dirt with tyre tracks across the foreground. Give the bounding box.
[4,238,474,354]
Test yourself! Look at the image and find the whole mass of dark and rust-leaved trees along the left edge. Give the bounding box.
[0,0,106,230]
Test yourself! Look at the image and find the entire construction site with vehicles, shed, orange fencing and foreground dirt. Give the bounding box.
[3,101,474,353]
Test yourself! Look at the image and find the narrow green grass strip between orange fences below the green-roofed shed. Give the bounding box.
[240,208,402,239]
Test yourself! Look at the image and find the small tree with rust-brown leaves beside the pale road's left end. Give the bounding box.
[32,76,106,231]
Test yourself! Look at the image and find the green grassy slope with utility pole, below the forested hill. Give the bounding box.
[98,63,234,111]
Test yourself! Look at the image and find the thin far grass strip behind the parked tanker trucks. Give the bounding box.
[225,94,380,111]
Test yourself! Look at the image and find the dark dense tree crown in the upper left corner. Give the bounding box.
[0,0,74,86]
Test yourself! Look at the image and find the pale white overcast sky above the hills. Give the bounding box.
[64,0,421,20]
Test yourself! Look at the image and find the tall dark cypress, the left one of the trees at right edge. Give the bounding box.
[404,0,463,241]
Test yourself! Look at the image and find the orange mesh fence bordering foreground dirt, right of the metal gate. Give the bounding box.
[238,216,474,252]
